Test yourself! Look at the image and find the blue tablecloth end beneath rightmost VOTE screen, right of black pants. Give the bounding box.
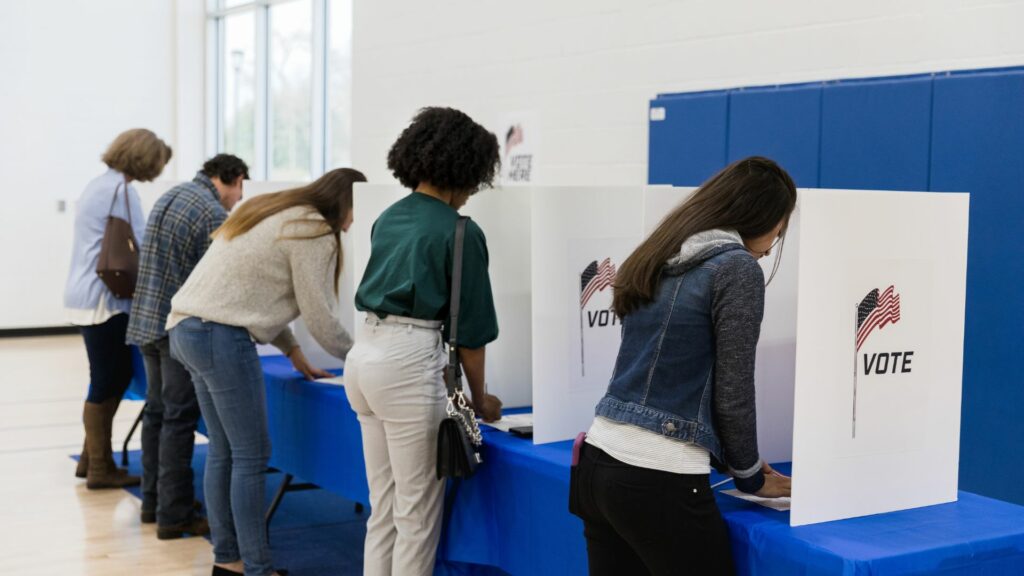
[718,464,1024,576]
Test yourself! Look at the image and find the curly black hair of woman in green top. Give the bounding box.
[387,108,501,194]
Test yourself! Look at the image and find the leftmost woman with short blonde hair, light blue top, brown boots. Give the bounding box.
[65,128,172,490]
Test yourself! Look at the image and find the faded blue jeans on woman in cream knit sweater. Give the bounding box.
[170,318,273,576]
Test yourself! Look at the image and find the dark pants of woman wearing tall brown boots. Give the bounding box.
[81,314,132,404]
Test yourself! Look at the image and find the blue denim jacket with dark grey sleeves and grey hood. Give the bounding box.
[596,231,764,492]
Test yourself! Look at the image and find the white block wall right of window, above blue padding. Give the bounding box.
[352,0,1024,184]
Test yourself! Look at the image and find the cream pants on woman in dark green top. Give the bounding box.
[345,315,446,576]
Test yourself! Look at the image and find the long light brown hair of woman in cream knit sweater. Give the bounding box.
[213,168,367,294]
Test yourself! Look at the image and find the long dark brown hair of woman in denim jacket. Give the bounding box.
[611,156,797,318]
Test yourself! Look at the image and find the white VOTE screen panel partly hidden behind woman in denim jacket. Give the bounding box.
[531,187,643,444]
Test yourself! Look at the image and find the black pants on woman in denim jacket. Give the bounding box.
[569,444,733,576]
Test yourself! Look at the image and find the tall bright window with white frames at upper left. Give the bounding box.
[208,0,352,180]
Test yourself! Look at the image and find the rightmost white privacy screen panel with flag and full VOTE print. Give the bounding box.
[790,190,969,526]
